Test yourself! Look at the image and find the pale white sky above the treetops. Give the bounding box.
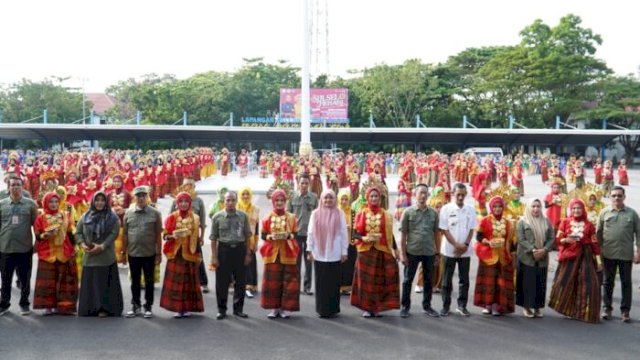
[0,0,640,92]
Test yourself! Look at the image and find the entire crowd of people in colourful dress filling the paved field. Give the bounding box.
[0,148,640,323]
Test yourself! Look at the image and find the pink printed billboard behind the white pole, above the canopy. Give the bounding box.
[280,89,349,122]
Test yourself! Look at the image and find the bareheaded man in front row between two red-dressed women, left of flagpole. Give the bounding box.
[209,191,253,320]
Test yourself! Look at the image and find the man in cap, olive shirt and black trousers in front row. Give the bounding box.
[120,186,162,318]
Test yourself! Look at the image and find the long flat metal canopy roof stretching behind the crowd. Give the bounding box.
[0,124,640,146]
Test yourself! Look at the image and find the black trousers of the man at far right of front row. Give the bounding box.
[604,257,633,312]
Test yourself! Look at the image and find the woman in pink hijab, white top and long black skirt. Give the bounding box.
[307,190,349,318]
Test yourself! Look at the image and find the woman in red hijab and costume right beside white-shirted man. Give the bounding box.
[473,196,515,316]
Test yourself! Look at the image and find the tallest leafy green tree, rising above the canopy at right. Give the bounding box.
[478,14,611,127]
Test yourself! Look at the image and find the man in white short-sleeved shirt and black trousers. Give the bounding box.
[439,183,478,316]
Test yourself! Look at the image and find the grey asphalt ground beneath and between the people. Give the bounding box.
[0,170,640,360]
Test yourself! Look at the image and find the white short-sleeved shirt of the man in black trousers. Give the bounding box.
[438,202,478,257]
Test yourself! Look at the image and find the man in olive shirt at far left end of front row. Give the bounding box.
[0,177,38,315]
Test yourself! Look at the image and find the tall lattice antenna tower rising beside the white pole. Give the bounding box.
[309,0,330,77]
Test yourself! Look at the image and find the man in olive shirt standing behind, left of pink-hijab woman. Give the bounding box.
[287,173,318,295]
